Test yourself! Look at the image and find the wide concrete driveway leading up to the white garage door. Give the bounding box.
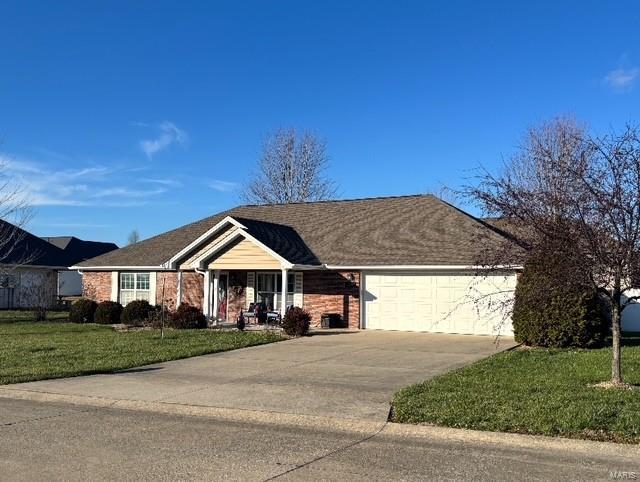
[0,331,515,421]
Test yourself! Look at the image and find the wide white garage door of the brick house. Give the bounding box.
[363,272,516,335]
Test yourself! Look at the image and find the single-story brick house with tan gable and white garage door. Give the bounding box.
[72,195,519,334]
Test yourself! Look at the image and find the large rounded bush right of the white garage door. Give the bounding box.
[513,250,608,348]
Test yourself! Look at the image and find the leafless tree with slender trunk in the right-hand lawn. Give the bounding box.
[465,118,640,386]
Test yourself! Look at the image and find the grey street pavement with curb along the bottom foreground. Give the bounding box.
[0,398,640,481]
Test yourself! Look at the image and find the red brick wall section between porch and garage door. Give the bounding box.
[303,271,360,328]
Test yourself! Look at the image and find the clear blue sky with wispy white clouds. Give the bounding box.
[0,0,640,244]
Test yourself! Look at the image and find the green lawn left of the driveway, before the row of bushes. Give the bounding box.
[0,323,283,384]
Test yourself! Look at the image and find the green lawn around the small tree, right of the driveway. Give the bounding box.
[392,337,640,443]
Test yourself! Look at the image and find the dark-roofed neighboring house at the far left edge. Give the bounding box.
[0,220,69,309]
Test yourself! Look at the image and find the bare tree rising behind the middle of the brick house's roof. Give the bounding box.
[242,129,336,204]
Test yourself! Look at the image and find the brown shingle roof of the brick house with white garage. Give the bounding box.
[80,195,516,267]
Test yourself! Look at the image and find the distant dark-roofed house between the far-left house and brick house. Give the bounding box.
[42,236,118,296]
